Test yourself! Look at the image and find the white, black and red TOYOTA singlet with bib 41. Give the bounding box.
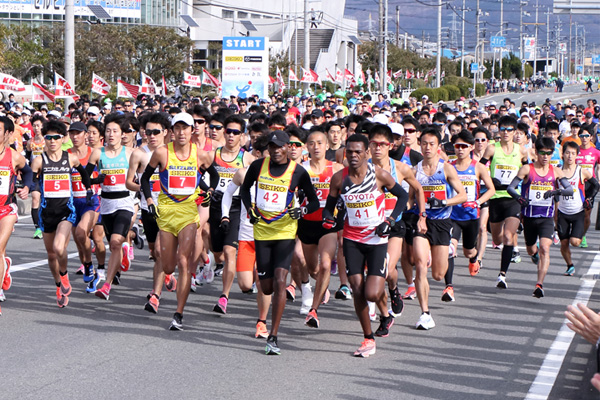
[340,163,388,245]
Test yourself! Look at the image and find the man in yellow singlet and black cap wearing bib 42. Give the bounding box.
[240,131,319,355]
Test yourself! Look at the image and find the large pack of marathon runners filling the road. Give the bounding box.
[0,92,600,357]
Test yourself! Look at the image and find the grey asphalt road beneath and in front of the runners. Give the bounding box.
[0,85,600,400]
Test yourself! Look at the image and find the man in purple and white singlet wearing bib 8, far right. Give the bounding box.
[507,137,573,298]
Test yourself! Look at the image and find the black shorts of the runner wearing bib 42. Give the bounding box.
[254,239,296,280]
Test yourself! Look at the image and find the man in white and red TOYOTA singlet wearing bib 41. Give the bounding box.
[323,134,408,358]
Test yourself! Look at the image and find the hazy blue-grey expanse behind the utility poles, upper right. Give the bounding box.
[345,0,600,55]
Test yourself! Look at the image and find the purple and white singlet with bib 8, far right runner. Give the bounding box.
[522,164,556,218]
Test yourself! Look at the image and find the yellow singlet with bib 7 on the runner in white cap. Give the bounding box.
[158,142,201,207]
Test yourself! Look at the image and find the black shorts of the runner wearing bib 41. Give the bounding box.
[343,239,388,278]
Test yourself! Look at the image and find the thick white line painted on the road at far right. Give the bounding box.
[525,254,600,400]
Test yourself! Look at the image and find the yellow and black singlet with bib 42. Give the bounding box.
[254,157,298,240]
